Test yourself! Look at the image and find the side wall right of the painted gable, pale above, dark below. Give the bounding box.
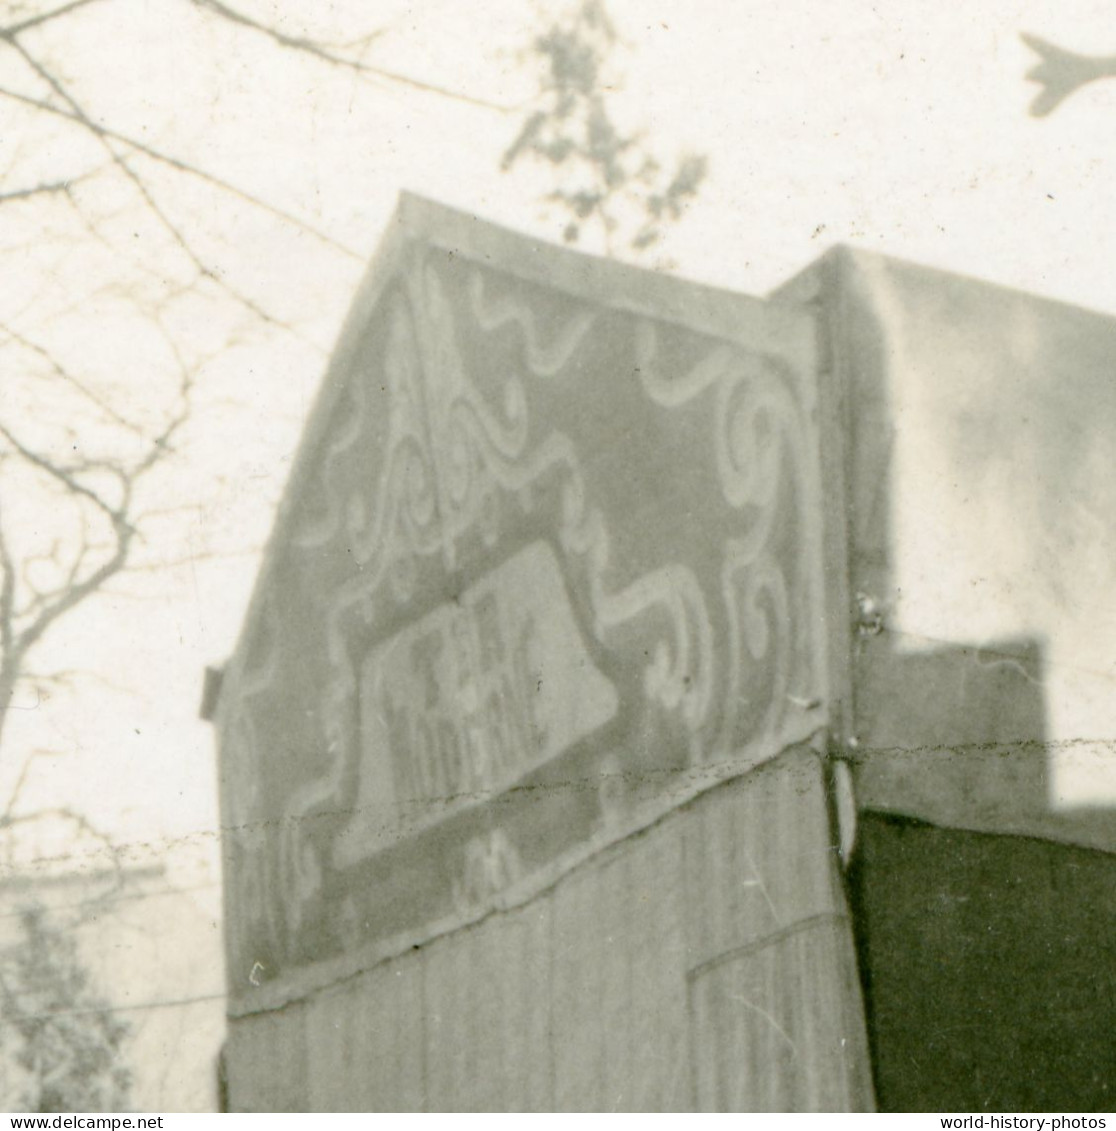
[777,249,1116,1112]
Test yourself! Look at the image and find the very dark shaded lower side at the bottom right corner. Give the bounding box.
[849,812,1116,1112]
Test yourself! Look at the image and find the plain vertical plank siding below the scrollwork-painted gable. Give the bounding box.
[230,748,872,1112]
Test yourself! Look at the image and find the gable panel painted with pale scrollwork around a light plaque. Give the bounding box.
[219,199,824,1010]
